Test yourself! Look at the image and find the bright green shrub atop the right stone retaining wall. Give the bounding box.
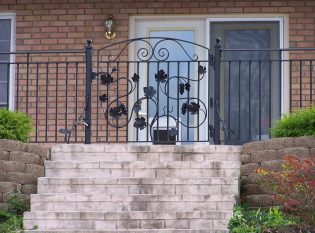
[271,107,315,138]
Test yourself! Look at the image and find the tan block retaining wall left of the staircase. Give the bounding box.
[0,139,48,209]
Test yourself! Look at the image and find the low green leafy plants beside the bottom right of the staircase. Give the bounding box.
[228,206,297,233]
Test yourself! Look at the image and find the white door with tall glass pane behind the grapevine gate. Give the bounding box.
[129,19,208,144]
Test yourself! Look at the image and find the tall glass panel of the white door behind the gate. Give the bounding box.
[143,30,195,143]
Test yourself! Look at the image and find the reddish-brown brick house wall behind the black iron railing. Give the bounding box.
[0,0,315,141]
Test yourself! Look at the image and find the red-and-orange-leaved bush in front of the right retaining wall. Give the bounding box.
[257,155,315,225]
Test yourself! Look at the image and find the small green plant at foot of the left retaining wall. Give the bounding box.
[0,192,27,233]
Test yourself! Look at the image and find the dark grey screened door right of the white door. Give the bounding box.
[210,21,281,144]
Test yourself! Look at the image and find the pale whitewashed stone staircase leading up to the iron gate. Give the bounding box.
[24,144,242,233]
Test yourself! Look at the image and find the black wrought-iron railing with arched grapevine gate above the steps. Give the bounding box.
[0,37,315,144]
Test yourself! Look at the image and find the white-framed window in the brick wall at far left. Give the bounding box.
[0,14,15,109]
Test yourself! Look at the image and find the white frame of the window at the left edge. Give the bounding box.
[0,12,16,111]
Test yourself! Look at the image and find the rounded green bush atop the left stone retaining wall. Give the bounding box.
[0,109,32,142]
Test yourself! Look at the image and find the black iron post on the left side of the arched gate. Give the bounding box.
[84,40,92,144]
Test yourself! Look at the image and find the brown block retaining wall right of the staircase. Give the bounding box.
[241,137,315,207]
